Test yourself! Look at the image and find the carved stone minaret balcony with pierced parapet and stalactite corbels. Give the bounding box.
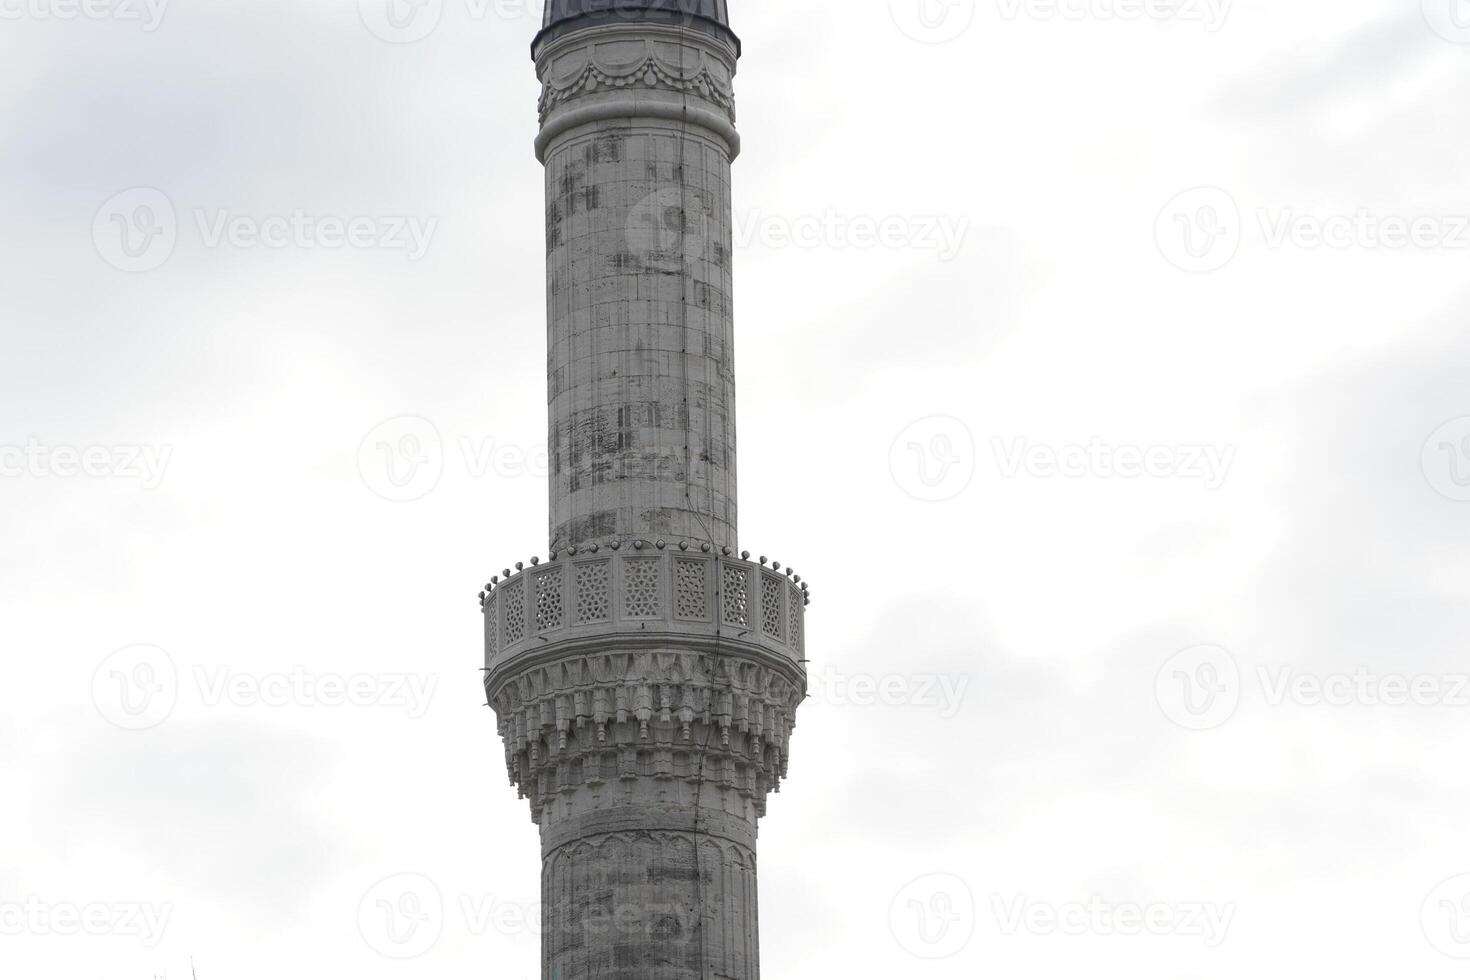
[481,542,809,822]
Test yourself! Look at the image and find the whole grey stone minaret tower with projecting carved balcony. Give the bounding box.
[481,0,807,980]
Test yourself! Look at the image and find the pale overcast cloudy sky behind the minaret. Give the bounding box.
[0,0,1470,980]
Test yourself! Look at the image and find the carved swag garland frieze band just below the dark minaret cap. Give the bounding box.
[539,38,735,123]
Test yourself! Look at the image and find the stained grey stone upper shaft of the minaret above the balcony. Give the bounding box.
[535,11,738,548]
